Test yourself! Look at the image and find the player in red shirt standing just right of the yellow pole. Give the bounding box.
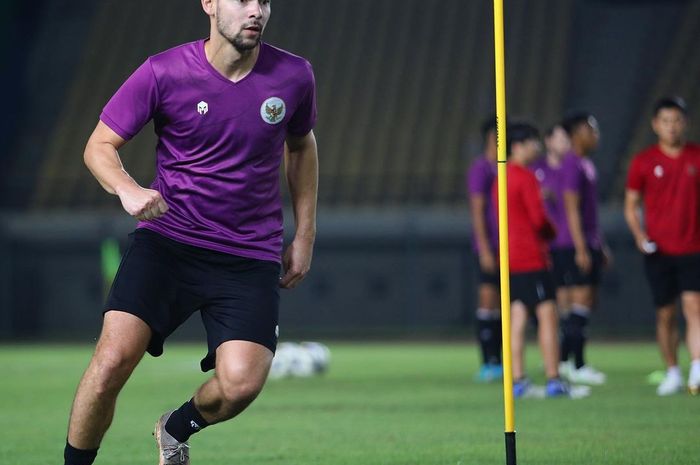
[493,123,569,397]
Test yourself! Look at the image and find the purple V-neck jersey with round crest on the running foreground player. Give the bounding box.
[100,40,316,261]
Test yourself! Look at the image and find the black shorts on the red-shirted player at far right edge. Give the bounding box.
[644,253,700,307]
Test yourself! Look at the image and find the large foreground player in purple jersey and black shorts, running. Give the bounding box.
[65,0,318,465]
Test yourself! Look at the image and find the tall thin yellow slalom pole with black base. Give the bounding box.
[493,0,517,465]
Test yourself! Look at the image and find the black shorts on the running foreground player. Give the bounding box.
[104,228,280,371]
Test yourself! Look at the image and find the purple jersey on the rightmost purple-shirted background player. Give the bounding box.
[557,152,602,249]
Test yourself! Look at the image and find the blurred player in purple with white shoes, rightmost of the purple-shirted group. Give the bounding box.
[552,112,609,385]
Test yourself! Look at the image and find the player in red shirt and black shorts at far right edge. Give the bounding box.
[625,97,700,396]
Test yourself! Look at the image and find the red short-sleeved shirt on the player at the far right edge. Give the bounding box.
[627,144,700,255]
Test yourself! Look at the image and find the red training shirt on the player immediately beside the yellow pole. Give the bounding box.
[493,163,556,273]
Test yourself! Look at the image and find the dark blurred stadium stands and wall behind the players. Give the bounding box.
[0,0,700,340]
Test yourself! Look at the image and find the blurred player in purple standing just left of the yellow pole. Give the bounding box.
[467,117,503,382]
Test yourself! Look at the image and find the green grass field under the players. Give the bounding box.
[0,344,700,465]
